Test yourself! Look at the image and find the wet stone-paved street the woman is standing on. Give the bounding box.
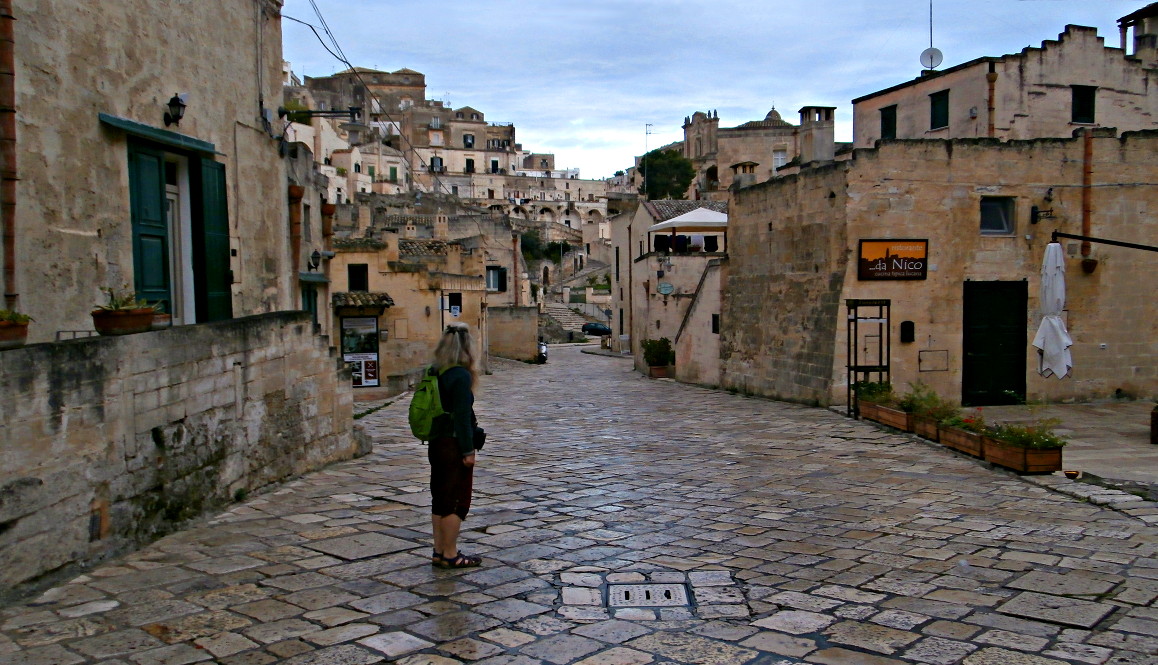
[0,348,1158,665]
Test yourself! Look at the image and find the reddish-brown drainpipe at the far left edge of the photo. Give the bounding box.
[0,0,20,309]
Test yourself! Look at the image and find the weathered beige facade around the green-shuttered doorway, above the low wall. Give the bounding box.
[10,0,291,342]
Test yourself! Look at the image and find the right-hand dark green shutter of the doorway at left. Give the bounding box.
[192,160,233,321]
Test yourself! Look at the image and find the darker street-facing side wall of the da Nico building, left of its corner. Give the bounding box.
[720,163,848,403]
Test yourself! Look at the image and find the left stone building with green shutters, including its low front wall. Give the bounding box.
[0,0,366,590]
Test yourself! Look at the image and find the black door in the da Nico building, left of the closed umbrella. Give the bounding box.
[961,282,1029,407]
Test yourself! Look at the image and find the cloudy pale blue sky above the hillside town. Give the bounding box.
[283,0,1150,178]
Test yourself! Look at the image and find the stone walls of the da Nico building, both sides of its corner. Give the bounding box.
[720,130,1158,404]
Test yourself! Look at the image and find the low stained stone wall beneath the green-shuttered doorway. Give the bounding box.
[0,313,369,597]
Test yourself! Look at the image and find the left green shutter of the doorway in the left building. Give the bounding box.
[129,144,171,312]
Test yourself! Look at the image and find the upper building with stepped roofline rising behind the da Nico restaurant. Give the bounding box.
[852,18,1158,147]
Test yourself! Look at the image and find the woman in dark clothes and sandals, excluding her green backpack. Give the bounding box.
[426,322,483,568]
